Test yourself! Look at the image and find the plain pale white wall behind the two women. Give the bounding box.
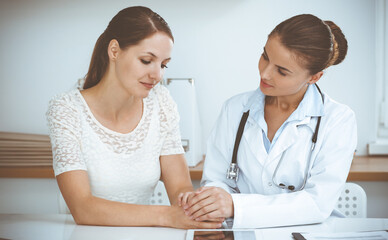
[0,0,376,155]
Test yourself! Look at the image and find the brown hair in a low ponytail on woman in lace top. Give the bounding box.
[83,6,174,89]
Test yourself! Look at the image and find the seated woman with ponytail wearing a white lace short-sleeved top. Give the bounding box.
[47,7,223,228]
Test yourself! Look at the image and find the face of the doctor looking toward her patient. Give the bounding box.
[259,35,312,97]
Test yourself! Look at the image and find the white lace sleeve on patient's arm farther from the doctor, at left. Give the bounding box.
[46,95,86,176]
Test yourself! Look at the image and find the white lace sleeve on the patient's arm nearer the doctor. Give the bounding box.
[156,86,184,155]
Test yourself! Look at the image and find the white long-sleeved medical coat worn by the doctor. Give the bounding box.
[201,85,357,228]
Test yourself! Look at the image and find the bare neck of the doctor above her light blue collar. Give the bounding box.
[265,87,307,112]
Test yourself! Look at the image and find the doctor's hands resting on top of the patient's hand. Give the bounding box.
[183,187,234,221]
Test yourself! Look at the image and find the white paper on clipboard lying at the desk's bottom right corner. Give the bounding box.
[292,231,388,240]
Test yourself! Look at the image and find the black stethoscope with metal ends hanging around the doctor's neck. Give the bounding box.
[226,84,324,192]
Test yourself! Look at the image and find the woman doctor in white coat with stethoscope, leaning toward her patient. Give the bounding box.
[179,14,357,228]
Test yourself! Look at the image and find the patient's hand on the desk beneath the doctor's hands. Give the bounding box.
[163,206,222,229]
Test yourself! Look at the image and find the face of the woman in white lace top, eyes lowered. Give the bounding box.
[114,32,173,98]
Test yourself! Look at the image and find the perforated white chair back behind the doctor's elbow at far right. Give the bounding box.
[336,182,367,218]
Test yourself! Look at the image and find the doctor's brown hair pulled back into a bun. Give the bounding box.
[268,14,348,74]
